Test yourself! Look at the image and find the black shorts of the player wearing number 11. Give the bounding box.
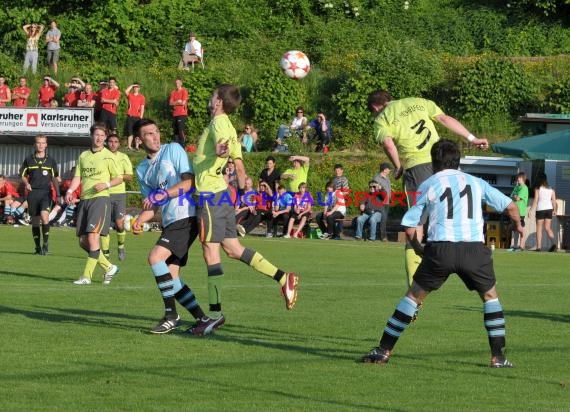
[414,242,496,294]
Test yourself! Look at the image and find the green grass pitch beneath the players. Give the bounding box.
[0,226,570,411]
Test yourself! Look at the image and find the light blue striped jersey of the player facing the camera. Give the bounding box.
[137,143,196,227]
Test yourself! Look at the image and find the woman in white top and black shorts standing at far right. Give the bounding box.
[532,173,556,252]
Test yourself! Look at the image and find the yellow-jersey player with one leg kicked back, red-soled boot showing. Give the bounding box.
[188,84,298,335]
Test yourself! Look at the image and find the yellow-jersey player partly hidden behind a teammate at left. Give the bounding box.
[101,134,133,260]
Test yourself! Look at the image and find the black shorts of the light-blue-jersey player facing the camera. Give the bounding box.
[156,216,198,266]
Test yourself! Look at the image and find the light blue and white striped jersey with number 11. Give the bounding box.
[402,169,512,242]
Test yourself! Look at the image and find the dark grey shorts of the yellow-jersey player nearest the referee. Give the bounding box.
[76,196,111,236]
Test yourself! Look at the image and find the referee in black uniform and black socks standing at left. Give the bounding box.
[20,134,59,255]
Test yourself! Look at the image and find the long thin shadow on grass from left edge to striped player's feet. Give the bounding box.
[0,305,156,330]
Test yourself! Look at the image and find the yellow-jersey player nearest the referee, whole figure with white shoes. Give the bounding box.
[65,123,123,285]
